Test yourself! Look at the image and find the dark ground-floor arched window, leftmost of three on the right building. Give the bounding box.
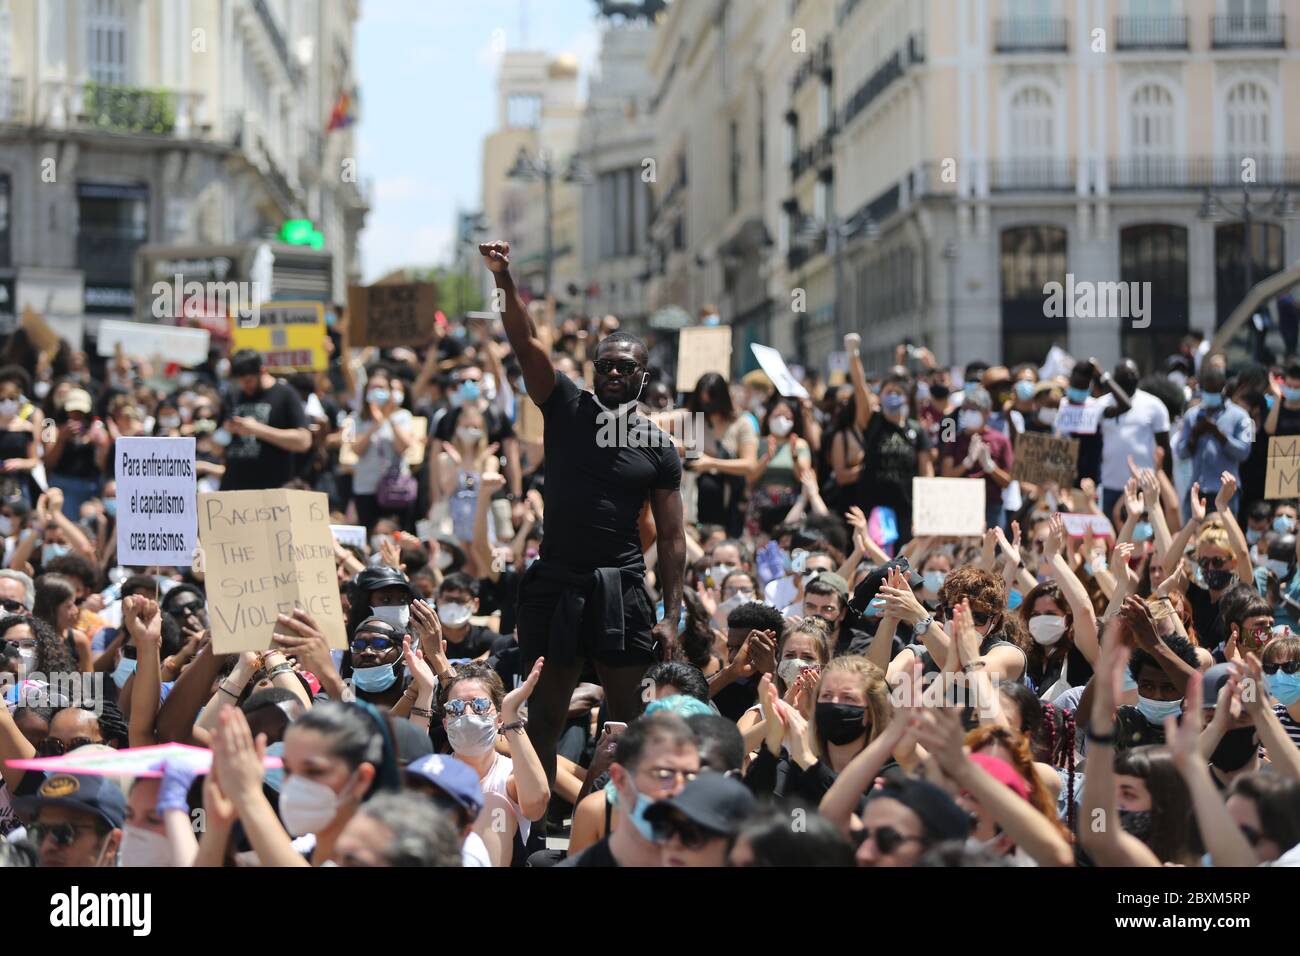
[1001,225,1070,365]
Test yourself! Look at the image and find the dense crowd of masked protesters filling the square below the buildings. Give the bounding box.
[0,243,1300,868]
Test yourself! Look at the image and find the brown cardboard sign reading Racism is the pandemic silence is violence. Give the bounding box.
[199,489,347,654]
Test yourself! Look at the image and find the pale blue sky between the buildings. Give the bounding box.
[356,0,599,281]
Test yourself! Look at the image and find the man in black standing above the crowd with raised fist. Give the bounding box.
[478,242,686,780]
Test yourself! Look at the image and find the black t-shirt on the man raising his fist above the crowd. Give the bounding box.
[541,375,681,571]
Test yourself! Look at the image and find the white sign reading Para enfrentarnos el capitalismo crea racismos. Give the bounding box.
[113,438,198,567]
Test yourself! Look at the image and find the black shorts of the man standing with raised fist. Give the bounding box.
[515,574,657,674]
